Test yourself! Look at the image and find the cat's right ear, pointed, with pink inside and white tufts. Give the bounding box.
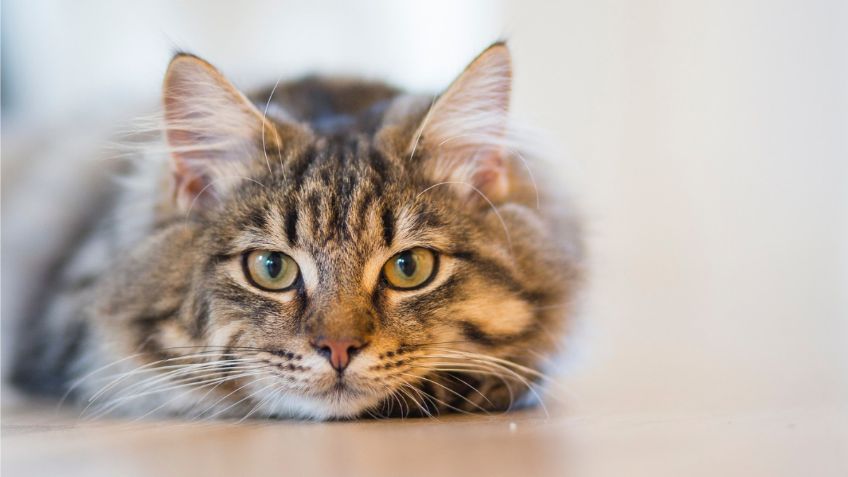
[411,43,512,203]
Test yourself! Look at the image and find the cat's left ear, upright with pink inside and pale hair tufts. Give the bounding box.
[163,53,280,208]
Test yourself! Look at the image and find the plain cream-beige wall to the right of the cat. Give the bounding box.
[507,1,848,416]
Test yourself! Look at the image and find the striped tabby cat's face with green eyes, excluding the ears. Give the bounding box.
[196,133,557,416]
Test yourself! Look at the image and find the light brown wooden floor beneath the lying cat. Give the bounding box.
[2,392,848,477]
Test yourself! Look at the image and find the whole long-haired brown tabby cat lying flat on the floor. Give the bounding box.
[13,42,585,419]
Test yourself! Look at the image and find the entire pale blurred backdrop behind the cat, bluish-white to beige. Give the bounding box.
[2,0,848,475]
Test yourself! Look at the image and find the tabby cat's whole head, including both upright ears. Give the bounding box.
[102,44,578,418]
